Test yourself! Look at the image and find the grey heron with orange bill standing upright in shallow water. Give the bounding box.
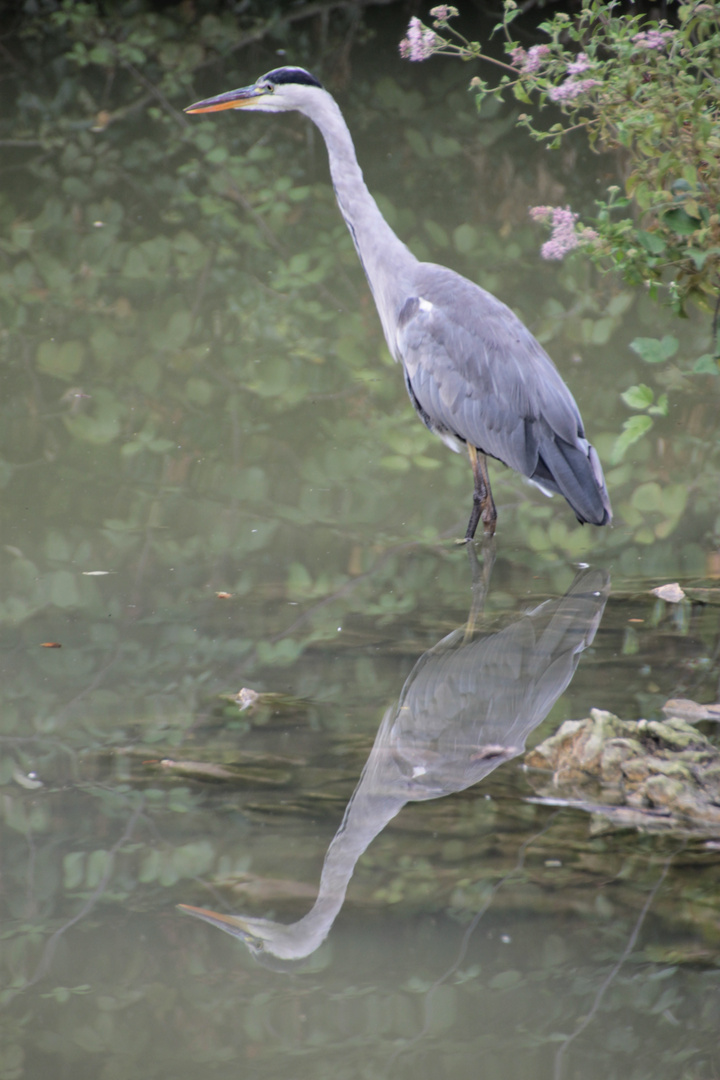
[185,67,612,541]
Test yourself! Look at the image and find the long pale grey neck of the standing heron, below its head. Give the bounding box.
[303,92,418,352]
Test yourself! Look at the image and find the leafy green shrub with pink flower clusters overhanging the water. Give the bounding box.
[411,0,720,329]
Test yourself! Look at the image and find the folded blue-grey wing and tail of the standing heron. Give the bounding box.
[396,264,610,524]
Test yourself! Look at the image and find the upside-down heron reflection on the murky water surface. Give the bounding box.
[179,569,609,961]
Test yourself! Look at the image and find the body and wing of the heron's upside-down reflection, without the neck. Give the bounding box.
[386,570,609,798]
